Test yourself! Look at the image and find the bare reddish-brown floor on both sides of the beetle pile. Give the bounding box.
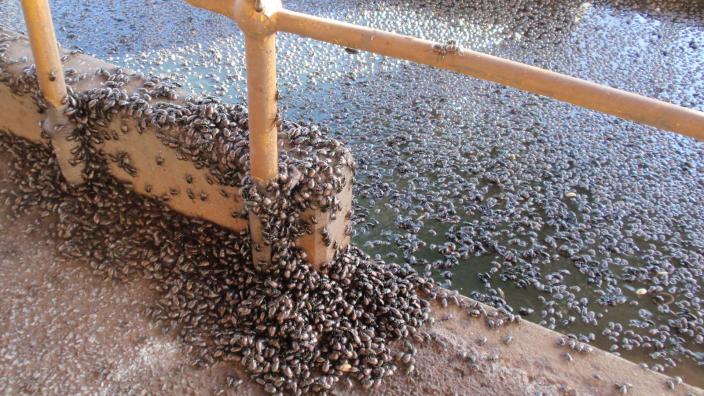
[0,153,704,395]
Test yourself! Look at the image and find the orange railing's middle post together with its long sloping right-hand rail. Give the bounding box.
[186,0,704,268]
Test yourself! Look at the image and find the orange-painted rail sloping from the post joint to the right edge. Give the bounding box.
[275,9,704,140]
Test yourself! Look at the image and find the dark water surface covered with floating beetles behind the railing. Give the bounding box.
[0,1,704,384]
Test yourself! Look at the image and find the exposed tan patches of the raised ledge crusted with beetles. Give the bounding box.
[0,31,353,268]
